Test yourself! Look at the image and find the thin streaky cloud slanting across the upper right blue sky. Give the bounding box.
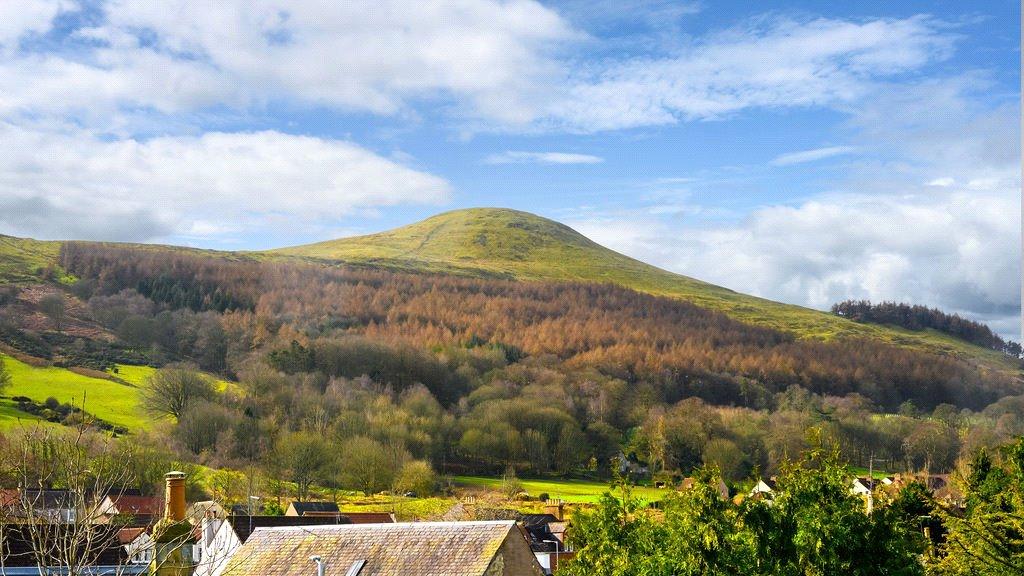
[546,16,953,131]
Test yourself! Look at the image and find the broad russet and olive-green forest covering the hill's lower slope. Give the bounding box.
[0,243,1003,491]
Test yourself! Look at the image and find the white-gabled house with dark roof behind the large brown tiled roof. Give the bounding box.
[193,513,348,576]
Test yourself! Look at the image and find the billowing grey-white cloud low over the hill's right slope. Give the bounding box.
[572,186,1020,339]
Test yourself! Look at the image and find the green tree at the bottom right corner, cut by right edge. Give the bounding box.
[935,438,1024,576]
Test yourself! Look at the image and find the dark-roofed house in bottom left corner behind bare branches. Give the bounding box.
[0,523,150,576]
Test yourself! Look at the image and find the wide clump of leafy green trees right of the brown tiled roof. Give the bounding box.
[559,451,925,576]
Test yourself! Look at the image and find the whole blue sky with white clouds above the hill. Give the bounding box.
[0,0,1021,339]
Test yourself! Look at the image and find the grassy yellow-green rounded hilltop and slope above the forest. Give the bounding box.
[268,208,1016,370]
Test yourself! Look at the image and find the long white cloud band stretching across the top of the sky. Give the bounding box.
[0,5,953,132]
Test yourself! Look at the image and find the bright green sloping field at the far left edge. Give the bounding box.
[0,356,151,429]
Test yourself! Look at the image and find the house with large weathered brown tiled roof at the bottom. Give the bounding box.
[224,521,543,576]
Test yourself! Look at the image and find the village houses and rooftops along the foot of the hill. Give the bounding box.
[0,471,963,576]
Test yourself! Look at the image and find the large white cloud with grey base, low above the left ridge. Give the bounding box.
[0,125,450,240]
